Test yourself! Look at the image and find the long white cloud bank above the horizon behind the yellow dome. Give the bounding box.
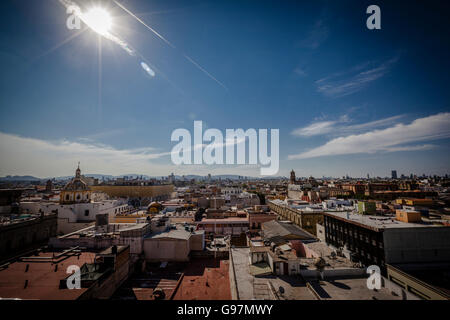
[0,132,170,177]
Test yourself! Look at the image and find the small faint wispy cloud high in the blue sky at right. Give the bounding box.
[315,57,398,98]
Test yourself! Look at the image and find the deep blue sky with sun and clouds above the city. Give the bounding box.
[0,0,450,177]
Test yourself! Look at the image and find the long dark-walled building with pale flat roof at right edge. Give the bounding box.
[324,212,450,272]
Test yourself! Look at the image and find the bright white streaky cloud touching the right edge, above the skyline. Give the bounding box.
[288,112,450,160]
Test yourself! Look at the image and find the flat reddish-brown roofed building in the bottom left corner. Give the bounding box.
[0,246,130,300]
